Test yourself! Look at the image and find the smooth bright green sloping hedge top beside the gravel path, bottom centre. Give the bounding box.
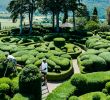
[46,81,76,100]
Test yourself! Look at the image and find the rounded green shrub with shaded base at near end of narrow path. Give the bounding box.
[71,74,87,91]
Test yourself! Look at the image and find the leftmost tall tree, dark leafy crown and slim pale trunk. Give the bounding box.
[7,0,25,35]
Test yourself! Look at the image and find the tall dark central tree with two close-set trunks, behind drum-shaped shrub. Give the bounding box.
[41,0,66,32]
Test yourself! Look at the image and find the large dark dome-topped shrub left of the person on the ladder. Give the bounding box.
[19,65,41,100]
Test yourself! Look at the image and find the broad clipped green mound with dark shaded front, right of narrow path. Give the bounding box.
[77,51,108,73]
